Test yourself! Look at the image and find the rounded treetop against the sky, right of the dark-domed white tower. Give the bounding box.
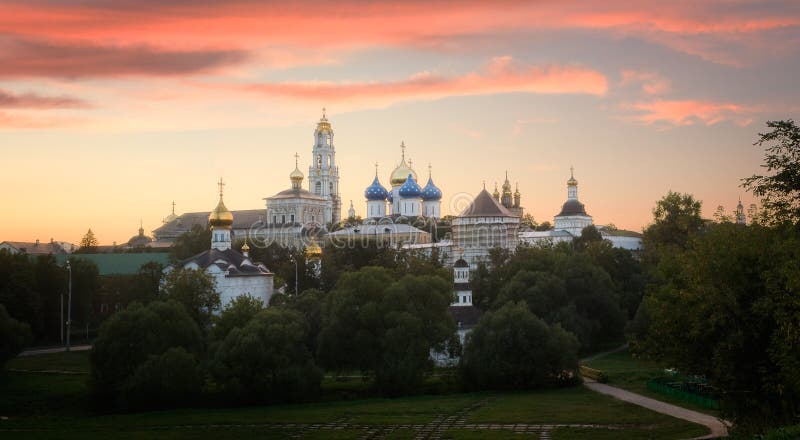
[644,191,703,251]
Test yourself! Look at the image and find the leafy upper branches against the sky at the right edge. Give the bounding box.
[742,119,800,224]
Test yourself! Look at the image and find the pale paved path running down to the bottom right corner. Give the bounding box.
[583,379,730,438]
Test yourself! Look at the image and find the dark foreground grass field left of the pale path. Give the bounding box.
[0,353,706,440]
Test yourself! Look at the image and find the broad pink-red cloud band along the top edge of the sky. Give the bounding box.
[0,0,800,73]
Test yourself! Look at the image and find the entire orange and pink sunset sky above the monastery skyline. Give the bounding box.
[0,0,800,244]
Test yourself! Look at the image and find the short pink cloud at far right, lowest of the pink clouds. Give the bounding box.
[631,100,755,126]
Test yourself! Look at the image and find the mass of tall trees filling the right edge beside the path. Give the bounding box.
[629,121,800,431]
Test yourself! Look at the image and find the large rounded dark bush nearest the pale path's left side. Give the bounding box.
[460,302,578,390]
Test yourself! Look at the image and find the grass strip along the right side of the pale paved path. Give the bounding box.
[586,350,720,417]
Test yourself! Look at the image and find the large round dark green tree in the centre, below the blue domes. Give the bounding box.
[318,267,455,395]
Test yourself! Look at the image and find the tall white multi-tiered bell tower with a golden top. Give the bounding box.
[308,108,342,223]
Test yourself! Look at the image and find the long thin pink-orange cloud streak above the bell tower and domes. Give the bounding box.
[236,57,608,105]
